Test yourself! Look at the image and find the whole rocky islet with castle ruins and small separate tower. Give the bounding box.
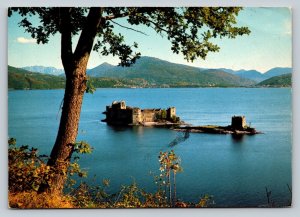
[101,100,261,135]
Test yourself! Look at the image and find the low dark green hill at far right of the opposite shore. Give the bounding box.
[256,73,292,87]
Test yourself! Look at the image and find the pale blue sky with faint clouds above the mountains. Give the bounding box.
[8,7,292,72]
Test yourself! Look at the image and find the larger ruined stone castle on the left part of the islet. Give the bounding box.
[102,100,184,127]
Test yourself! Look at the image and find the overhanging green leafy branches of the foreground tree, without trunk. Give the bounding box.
[8,7,250,66]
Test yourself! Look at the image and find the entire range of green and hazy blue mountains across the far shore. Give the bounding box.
[9,56,292,88]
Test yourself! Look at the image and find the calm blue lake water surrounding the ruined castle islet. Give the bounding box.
[8,88,292,207]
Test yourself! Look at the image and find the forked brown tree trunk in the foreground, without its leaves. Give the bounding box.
[39,8,102,194]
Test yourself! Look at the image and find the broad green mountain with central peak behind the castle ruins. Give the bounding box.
[88,56,255,87]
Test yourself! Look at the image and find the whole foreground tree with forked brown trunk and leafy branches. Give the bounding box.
[8,7,250,194]
